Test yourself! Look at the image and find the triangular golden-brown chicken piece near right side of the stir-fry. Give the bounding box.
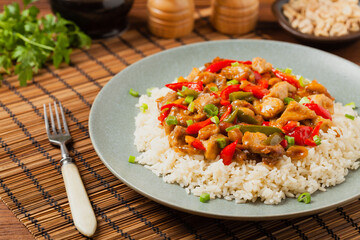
[276,101,317,126]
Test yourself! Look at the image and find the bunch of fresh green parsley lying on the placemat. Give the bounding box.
[0,0,91,86]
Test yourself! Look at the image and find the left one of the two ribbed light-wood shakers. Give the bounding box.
[147,0,194,38]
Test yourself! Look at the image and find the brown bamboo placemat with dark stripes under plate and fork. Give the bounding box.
[0,1,360,239]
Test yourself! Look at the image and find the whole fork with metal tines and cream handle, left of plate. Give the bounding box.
[44,102,97,237]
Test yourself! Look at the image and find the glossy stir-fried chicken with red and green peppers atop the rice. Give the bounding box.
[157,57,334,165]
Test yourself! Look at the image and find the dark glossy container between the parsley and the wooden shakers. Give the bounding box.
[50,0,133,38]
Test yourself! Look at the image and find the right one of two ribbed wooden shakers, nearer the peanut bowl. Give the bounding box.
[211,0,259,34]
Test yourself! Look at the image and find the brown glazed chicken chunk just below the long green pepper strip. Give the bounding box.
[242,132,285,157]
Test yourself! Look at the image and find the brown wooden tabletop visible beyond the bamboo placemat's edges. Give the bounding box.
[0,0,360,240]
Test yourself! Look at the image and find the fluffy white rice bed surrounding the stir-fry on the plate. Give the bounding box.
[134,88,360,204]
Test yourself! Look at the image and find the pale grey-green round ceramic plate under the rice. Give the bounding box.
[89,40,360,220]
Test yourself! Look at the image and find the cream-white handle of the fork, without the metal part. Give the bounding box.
[61,162,97,237]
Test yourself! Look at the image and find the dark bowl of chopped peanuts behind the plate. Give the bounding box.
[272,0,360,44]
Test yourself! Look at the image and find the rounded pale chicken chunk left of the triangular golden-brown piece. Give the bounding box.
[255,97,285,119]
